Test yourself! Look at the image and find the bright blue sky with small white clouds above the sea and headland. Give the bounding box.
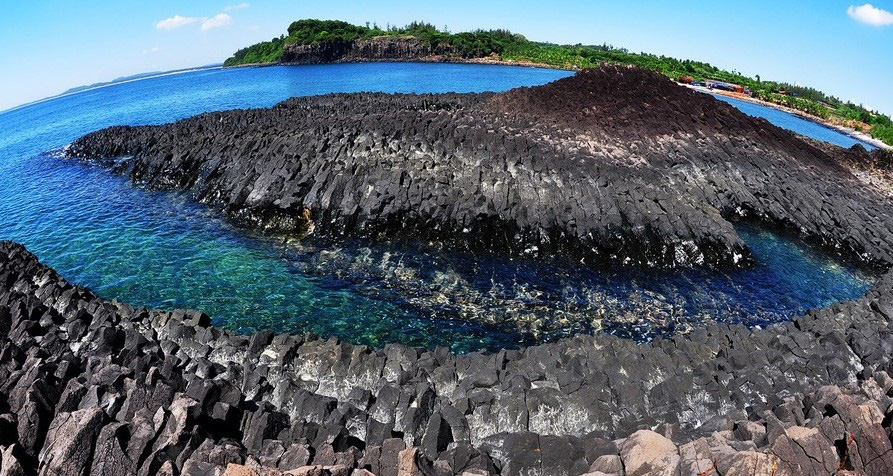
[0,0,893,114]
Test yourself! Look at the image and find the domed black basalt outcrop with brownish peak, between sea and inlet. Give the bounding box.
[68,67,893,266]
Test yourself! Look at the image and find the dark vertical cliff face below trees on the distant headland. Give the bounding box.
[282,36,453,64]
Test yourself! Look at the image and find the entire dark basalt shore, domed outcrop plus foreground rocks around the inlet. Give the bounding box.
[0,68,893,476]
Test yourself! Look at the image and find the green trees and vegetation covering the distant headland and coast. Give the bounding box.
[224,19,893,145]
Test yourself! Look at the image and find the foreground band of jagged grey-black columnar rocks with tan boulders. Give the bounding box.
[0,242,893,476]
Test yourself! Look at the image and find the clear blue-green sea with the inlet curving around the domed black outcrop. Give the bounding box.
[0,63,873,352]
